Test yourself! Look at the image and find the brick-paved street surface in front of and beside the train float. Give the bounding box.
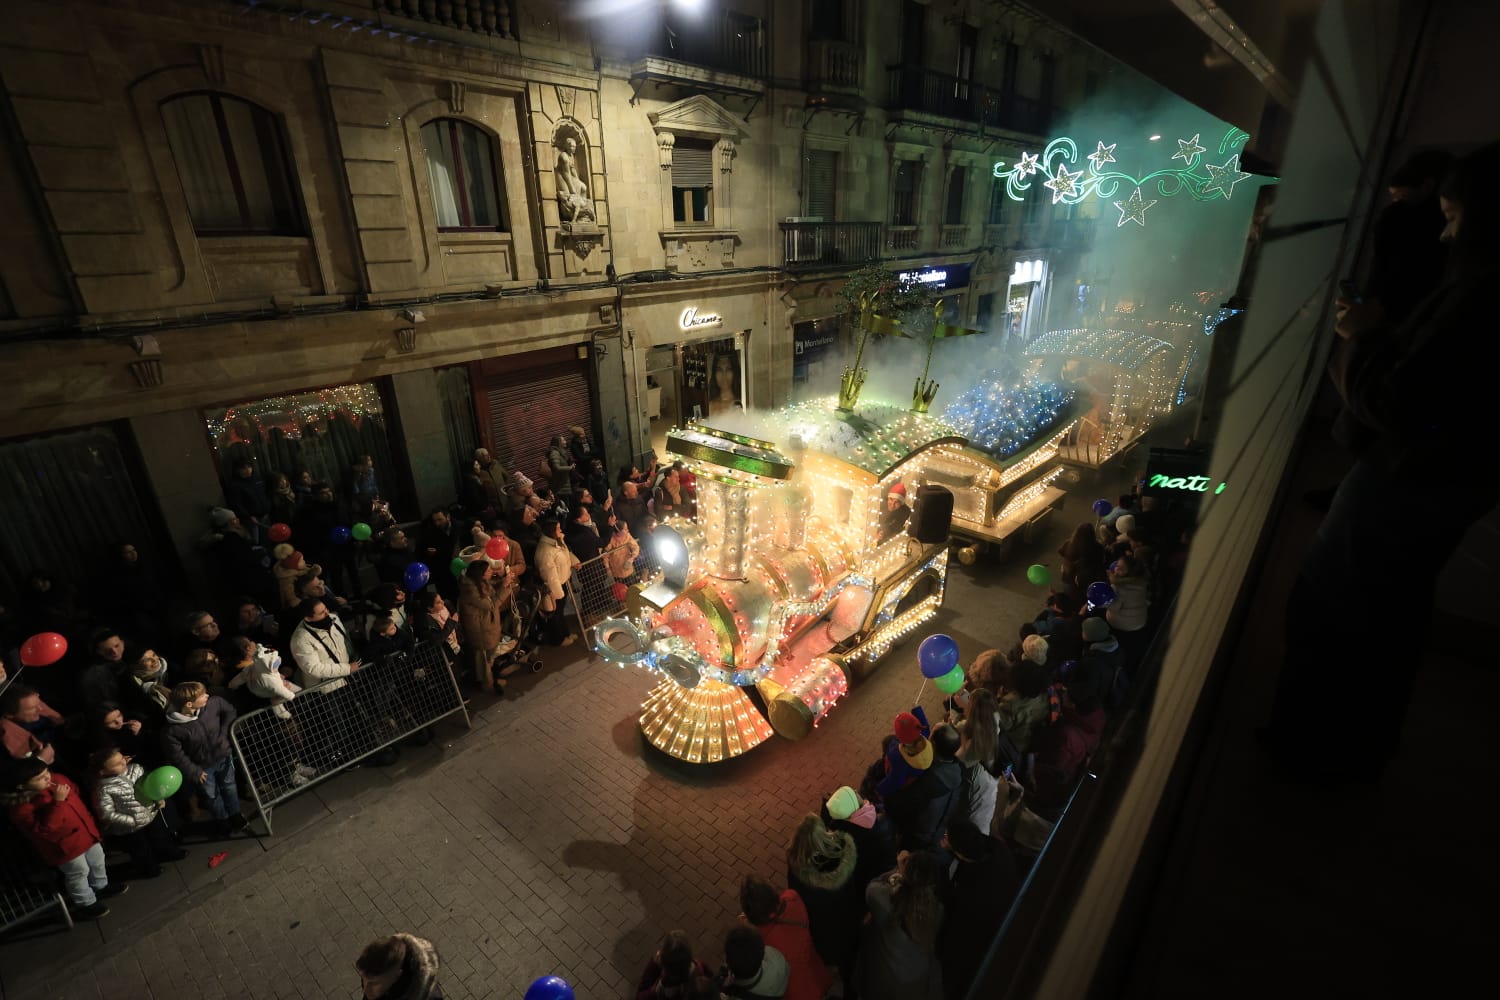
[0,554,1056,1000]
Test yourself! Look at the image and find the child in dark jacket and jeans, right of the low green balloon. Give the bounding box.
[162,681,246,834]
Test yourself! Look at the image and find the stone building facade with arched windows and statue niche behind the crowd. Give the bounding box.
[0,0,1107,589]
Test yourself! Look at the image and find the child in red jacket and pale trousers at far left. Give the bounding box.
[0,757,120,919]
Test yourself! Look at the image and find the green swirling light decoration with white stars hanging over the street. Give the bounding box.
[992,127,1274,218]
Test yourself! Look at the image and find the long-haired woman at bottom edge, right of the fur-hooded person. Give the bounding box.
[855,850,944,1000]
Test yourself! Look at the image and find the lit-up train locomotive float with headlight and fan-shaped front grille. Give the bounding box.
[594,399,1074,763]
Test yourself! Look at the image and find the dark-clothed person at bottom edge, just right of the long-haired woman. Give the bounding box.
[938,816,1020,1000]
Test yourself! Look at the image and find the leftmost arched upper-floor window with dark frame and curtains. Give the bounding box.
[162,93,306,235]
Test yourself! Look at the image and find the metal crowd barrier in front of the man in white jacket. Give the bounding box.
[230,640,471,834]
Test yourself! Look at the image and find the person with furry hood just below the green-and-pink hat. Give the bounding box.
[786,813,864,982]
